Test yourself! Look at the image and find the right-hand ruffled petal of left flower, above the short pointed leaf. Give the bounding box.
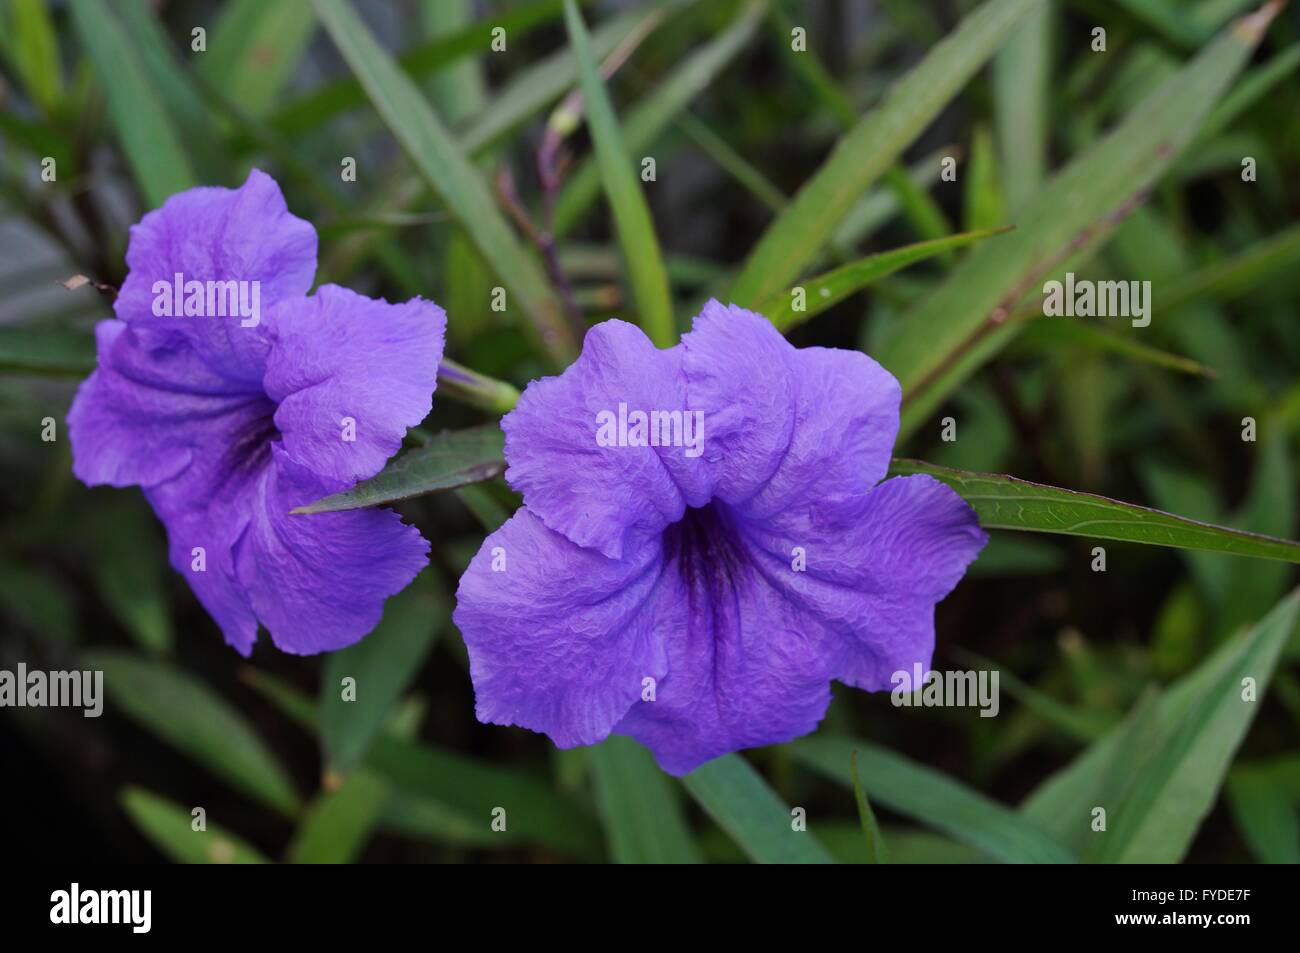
[264,285,447,491]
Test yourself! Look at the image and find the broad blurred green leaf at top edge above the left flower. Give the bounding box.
[199,0,316,116]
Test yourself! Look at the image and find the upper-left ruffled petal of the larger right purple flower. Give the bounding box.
[502,321,711,558]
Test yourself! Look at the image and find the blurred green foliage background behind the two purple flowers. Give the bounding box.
[0,0,1300,862]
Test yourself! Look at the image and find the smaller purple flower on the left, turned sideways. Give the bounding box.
[68,170,446,655]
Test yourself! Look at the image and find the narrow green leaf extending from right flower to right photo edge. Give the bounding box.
[889,459,1300,563]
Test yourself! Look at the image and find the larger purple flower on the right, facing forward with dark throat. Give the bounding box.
[455,302,987,775]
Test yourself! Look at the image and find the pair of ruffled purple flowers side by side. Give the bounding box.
[69,173,985,774]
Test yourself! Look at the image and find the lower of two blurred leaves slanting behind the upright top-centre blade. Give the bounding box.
[554,0,767,235]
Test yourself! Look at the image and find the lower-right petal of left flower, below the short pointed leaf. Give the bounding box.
[234,445,429,655]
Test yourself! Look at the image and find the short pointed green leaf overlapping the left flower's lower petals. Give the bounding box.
[291,424,506,514]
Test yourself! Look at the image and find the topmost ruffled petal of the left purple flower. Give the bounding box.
[113,169,316,384]
